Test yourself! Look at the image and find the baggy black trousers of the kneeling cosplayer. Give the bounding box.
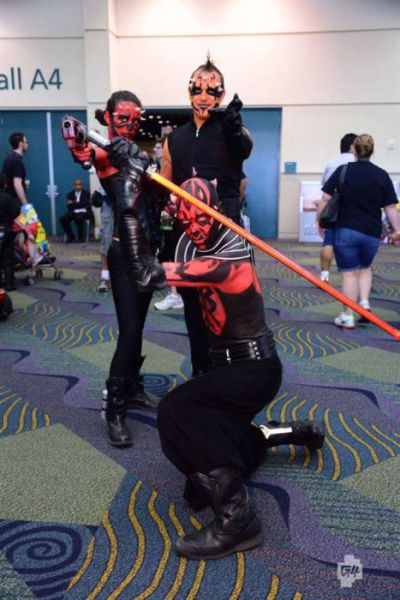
[158,359,282,476]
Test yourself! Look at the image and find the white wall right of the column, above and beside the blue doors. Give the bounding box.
[111,0,400,237]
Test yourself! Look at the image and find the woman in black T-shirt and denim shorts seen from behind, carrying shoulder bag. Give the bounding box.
[317,133,400,329]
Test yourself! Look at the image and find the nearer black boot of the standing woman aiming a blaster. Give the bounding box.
[106,377,133,446]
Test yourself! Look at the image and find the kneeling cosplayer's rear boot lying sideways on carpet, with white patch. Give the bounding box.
[259,420,325,450]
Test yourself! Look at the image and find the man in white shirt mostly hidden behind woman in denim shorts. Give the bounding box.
[320,133,357,281]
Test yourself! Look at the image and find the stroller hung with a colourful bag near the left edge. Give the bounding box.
[13,204,62,285]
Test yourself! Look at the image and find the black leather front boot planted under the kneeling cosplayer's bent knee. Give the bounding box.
[176,467,262,560]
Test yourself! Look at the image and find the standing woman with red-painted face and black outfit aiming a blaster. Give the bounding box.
[66,91,164,446]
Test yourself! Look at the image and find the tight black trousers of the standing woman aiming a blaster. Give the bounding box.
[107,242,152,379]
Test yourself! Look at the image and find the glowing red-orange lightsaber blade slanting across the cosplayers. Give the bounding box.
[147,170,400,341]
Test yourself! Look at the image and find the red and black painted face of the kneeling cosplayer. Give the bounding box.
[177,177,219,250]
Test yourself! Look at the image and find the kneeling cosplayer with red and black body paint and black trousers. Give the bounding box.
[158,178,324,559]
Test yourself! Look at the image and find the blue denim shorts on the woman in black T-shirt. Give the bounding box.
[333,227,380,271]
